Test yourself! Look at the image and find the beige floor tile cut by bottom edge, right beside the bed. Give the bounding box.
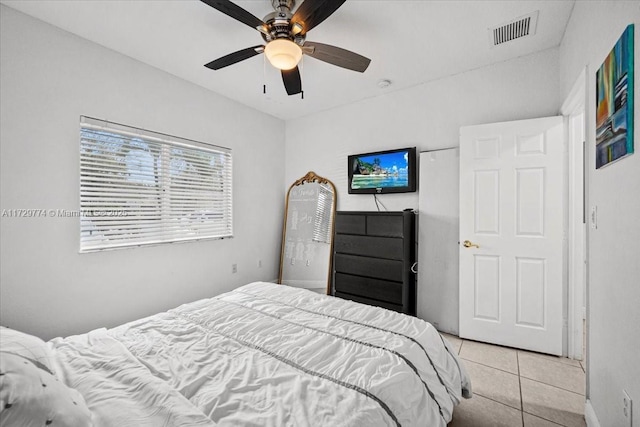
[449,395,522,427]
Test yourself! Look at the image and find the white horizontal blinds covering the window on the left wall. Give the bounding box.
[80,117,233,252]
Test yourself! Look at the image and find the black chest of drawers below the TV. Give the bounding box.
[332,210,417,316]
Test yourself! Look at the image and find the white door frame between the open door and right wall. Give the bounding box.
[560,68,587,360]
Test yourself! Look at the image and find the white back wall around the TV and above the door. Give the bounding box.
[285,49,560,210]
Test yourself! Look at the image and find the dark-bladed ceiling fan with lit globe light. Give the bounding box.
[201,0,371,95]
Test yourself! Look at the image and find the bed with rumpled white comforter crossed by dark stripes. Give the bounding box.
[0,282,471,427]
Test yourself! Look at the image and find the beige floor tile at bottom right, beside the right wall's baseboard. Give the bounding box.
[520,378,586,427]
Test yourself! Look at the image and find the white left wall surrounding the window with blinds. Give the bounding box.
[0,6,285,339]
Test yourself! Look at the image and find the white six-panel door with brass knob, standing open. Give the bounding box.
[460,117,565,355]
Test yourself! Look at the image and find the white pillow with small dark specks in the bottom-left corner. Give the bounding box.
[0,351,93,427]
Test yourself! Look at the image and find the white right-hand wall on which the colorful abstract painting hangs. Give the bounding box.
[560,1,640,427]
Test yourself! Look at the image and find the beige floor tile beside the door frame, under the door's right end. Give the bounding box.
[518,351,586,394]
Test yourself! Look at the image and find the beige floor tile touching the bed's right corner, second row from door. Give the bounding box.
[464,360,522,410]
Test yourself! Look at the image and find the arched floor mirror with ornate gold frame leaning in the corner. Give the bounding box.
[278,172,336,294]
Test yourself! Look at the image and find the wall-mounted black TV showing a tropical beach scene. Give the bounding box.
[348,147,416,194]
